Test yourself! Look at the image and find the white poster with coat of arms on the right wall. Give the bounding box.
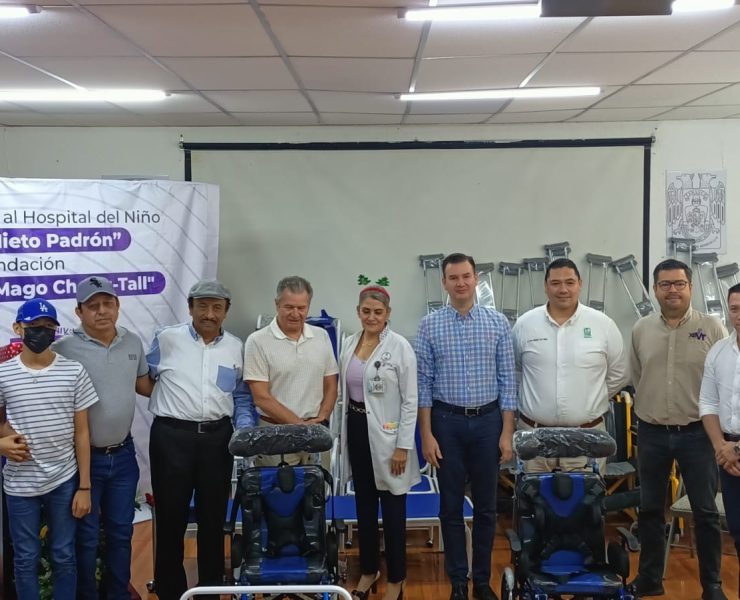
[666,171,727,256]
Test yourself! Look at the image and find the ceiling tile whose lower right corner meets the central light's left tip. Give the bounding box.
[291,57,414,93]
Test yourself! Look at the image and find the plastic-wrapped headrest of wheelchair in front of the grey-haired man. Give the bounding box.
[229,425,332,456]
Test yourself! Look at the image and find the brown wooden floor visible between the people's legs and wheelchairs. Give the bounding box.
[132,519,738,600]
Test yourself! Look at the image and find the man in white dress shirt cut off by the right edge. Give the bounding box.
[699,284,740,588]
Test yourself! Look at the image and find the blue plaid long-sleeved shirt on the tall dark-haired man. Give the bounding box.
[416,304,517,411]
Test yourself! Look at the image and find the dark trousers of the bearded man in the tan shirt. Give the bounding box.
[638,421,722,589]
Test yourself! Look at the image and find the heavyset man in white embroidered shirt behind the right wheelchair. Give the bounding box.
[511,258,628,472]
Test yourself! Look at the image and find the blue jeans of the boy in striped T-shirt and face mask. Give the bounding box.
[5,475,77,600]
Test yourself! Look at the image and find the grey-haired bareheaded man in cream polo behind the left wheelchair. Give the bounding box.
[244,276,339,466]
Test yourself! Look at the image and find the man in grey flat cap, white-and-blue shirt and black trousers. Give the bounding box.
[147,280,254,600]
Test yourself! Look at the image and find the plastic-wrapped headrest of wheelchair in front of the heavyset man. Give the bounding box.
[514,427,617,460]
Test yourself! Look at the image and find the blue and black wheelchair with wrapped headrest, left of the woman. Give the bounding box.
[225,425,338,586]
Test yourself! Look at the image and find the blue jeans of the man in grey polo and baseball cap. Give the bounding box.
[77,439,139,600]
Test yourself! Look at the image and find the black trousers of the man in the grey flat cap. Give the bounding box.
[149,418,233,600]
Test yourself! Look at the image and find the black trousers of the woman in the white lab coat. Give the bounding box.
[347,410,404,583]
